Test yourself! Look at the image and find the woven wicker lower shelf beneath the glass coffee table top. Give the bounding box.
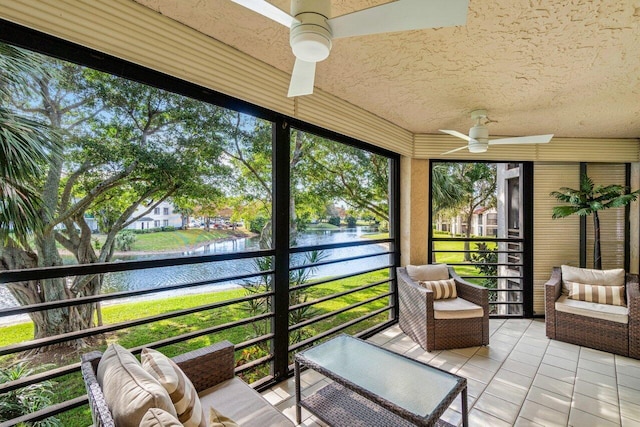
[300,383,453,427]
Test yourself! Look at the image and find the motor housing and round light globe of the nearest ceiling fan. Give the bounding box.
[289,0,332,62]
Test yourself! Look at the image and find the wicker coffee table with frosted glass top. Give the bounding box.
[295,335,468,427]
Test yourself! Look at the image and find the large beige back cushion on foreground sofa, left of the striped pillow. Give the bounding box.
[97,344,176,427]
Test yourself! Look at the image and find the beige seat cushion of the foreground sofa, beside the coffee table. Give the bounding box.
[200,377,293,427]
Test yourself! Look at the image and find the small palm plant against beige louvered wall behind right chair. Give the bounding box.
[551,174,640,270]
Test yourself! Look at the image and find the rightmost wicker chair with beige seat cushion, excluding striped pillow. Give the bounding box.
[544,266,640,359]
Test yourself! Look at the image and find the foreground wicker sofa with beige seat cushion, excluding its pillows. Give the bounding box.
[81,341,294,427]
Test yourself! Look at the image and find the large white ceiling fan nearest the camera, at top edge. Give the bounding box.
[232,0,468,97]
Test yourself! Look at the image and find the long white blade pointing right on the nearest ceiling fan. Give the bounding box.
[327,0,469,39]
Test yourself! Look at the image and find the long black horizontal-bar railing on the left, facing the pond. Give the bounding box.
[0,239,396,427]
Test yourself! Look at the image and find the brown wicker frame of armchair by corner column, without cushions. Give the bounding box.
[397,267,489,351]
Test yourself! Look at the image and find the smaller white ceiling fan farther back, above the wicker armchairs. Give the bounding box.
[440,110,553,155]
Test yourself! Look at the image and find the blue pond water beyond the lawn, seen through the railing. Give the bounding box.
[0,227,389,323]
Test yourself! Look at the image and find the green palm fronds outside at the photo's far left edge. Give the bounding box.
[0,43,59,245]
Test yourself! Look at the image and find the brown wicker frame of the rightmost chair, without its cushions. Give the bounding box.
[544,267,640,359]
